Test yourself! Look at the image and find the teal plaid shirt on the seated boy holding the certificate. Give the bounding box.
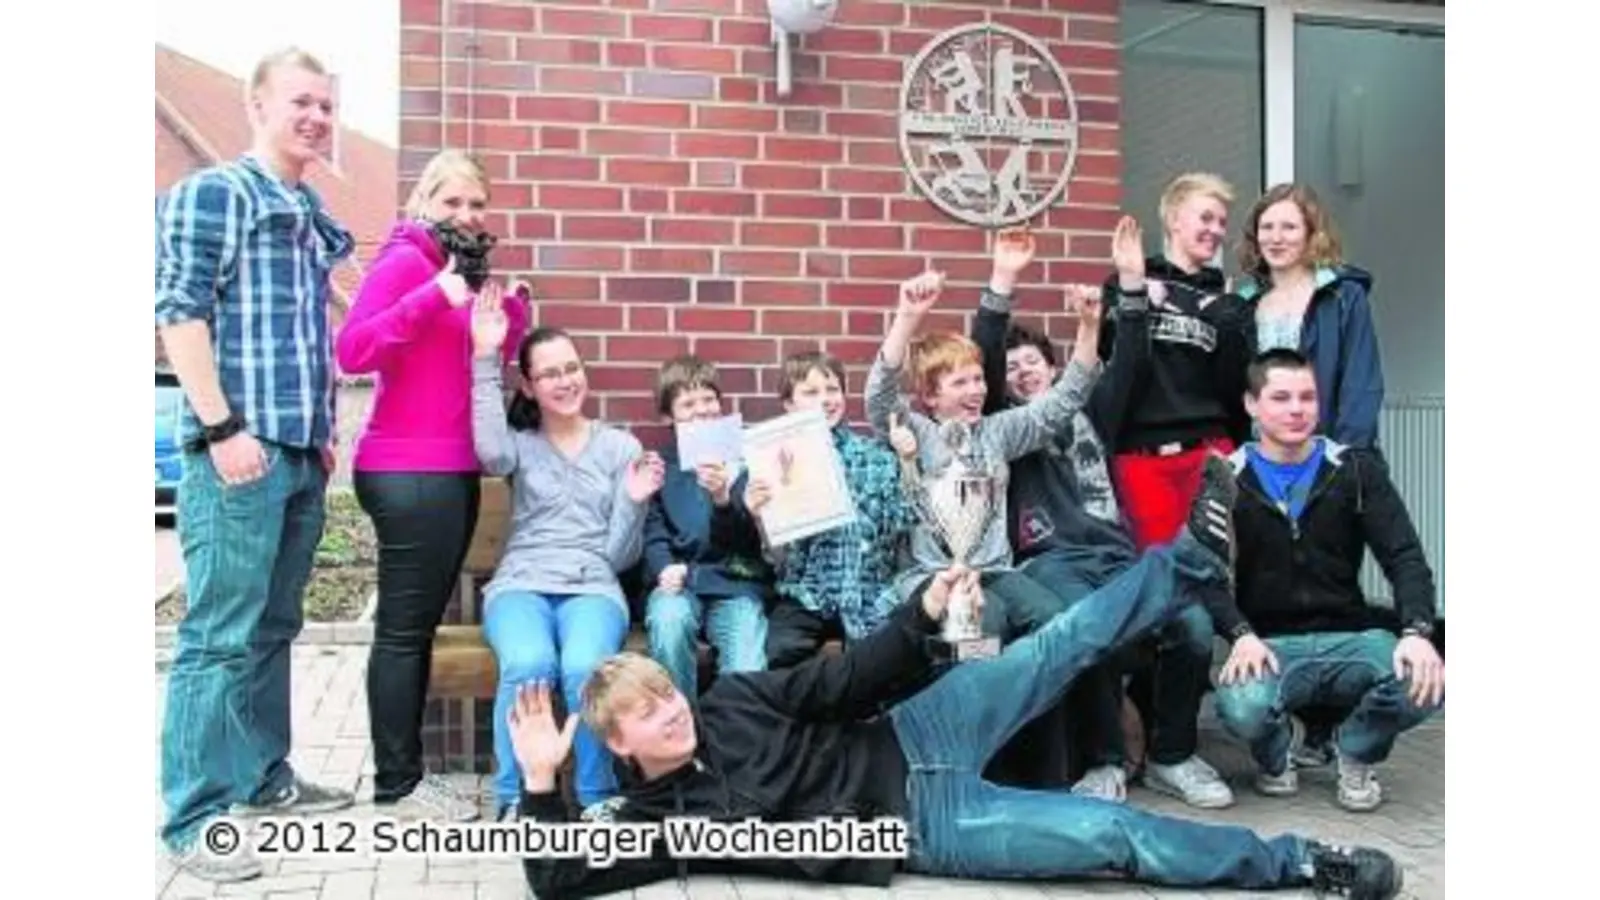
[778,426,915,641]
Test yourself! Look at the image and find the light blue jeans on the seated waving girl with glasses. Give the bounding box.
[483,591,627,807]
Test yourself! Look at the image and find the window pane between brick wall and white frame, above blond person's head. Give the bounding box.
[1120,0,1262,253]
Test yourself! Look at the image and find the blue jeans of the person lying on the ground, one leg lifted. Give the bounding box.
[890,535,1309,889]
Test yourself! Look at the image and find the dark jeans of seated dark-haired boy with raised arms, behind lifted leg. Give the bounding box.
[1022,551,1214,765]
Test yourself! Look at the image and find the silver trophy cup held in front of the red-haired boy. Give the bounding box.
[907,423,1000,660]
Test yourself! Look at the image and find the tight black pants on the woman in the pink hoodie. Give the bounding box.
[355,472,478,804]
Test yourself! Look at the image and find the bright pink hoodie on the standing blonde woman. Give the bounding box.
[338,221,528,472]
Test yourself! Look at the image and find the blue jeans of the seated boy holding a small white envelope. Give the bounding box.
[645,588,766,705]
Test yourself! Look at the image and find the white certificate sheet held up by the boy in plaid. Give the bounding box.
[744,410,856,548]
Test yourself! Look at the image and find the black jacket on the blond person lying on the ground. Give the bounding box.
[522,592,941,900]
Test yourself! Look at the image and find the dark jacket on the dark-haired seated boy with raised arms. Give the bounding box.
[973,288,1146,572]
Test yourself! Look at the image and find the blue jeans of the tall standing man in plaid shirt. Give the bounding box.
[162,442,328,850]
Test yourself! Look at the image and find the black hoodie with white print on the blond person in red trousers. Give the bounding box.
[1091,256,1251,453]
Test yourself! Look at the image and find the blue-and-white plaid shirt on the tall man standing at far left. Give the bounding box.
[155,155,355,448]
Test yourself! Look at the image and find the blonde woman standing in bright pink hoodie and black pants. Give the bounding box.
[338,151,528,822]
